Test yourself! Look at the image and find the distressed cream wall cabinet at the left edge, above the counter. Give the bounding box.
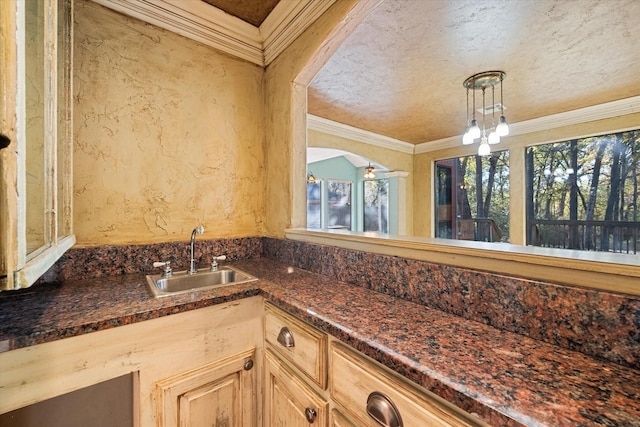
[0,0,75,290]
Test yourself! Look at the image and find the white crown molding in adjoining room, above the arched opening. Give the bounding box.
[307,114,414,154]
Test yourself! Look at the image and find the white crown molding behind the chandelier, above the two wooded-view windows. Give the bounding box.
[415,96,640,154]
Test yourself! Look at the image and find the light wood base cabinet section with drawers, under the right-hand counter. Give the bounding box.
[264,303,486,427]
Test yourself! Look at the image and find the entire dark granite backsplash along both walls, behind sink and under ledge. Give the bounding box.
[40,237,640,369]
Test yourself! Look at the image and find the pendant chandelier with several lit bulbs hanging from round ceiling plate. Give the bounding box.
[462,71,509,156]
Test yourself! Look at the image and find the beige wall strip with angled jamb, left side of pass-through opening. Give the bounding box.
[265,0,380,237]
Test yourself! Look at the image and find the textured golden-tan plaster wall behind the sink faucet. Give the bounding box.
[74,0,265,246]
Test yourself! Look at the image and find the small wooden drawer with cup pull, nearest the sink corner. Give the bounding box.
[264,304,327,389]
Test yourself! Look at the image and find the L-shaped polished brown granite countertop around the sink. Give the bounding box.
[0,259,640,426]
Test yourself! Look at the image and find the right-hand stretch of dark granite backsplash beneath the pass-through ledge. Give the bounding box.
[263,238,640,369]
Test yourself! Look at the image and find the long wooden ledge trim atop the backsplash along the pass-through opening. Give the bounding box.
[285,229,640,295]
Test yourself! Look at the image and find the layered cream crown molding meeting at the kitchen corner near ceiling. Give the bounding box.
[93,0,336,67]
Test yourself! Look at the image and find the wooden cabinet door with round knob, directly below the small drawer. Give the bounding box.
[264,351,329,427]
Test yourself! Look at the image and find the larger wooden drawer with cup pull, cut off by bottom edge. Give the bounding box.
[329,342,486,427]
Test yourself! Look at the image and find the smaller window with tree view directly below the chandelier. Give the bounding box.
[435,151,509,242]
